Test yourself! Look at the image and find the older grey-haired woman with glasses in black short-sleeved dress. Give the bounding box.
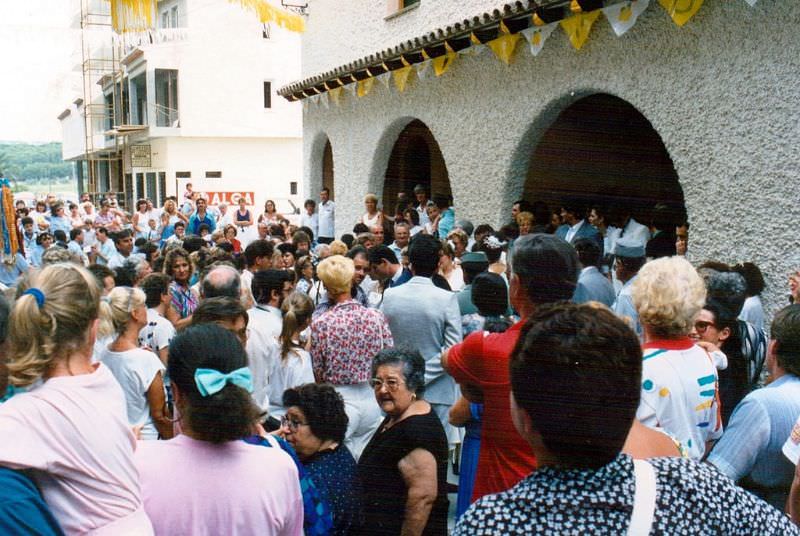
[358,348,448,535]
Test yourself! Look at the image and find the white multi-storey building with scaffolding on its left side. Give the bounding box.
[59,0,302,217]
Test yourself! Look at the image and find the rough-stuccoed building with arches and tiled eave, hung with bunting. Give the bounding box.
[280,0,800,316]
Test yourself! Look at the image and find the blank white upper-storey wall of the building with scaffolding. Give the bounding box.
[136,0,302,137]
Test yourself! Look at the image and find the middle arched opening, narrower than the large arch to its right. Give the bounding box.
[382,119,452,211]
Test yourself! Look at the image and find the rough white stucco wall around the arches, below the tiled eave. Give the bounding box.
[304,1,800,318]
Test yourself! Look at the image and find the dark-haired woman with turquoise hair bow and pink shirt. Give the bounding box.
[136,323,303,535]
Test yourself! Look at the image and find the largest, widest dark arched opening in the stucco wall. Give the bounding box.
[523,93,686,230]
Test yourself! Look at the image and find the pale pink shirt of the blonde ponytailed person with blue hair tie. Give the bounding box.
[0,364,152,534]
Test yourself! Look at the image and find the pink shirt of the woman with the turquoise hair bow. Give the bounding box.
[136,435,303,536]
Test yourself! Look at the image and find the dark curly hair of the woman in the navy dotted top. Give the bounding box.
[283,383,348,443]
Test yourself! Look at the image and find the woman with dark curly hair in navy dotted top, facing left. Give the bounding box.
[280,383,361,535]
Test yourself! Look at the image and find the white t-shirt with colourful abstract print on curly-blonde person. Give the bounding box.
[636,338,722,461]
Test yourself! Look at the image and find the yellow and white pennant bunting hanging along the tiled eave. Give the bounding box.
[298,0,758,105]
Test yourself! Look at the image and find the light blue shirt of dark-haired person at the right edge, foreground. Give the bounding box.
[708,374,800,510]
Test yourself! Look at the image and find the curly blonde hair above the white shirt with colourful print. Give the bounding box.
[631,256,706,338]
